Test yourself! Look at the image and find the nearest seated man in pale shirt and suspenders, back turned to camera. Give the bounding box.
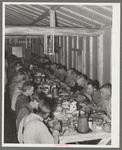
[18,97,59,144]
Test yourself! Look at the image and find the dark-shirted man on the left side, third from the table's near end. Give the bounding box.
[15,81,34,116]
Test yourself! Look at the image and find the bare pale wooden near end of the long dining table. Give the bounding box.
[59,122,111,145]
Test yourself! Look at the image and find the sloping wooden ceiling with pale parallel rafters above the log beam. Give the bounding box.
[5,3,113,29]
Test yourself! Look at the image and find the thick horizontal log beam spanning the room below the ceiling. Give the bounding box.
[5,26,104,36]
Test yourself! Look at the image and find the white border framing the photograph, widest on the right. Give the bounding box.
[2,2,120,148]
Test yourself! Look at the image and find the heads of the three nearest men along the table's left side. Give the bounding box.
[18,81,59,119]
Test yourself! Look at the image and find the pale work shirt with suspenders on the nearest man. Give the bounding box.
[18,113,59,144]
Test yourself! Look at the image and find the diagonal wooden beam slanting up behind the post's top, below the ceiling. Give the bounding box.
[30,5,62,26]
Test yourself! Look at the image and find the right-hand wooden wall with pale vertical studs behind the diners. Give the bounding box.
[51,28,111,86]
